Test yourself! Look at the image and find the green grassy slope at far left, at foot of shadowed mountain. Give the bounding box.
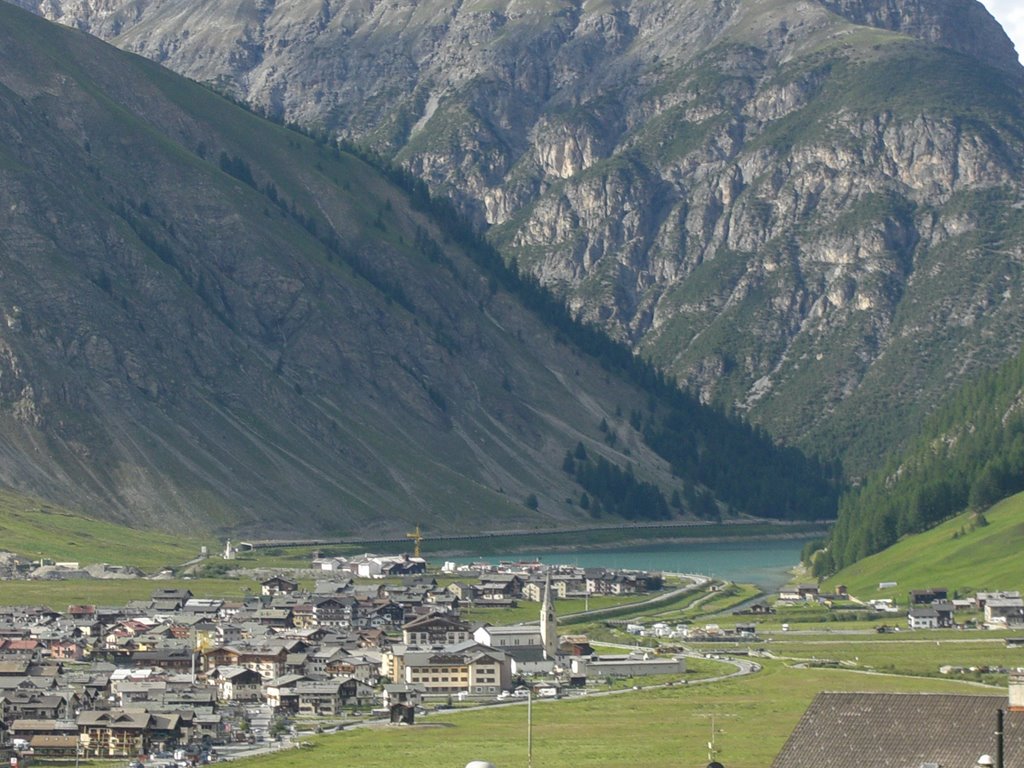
[0,489,204,572]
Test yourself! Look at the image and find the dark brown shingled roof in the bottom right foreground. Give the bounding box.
[772,693,1024,768]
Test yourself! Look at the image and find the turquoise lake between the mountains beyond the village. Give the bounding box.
[450,539,808,592]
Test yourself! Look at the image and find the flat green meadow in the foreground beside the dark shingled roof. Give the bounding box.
[234,663,991,768]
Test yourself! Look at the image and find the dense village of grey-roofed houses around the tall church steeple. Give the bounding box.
[0,553,685,765]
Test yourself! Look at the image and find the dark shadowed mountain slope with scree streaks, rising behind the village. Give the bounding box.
[0,3,835,536]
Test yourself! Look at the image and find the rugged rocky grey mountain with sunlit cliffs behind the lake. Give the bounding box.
[19,0,1024,476]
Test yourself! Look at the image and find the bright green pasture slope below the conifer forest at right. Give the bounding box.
[825,494,1024,604]
